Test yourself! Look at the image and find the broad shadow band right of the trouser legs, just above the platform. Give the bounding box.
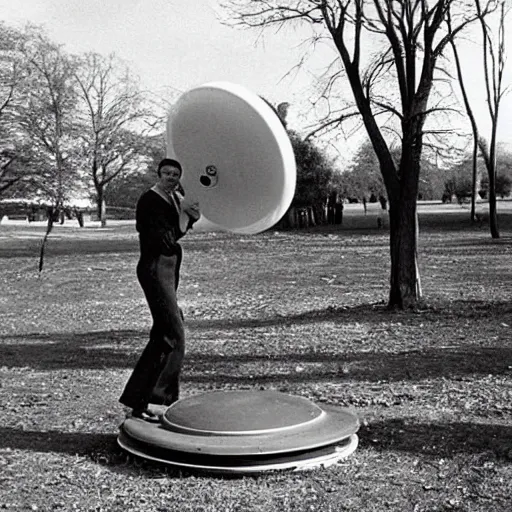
[183,346,512,385]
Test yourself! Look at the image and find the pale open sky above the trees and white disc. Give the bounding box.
[0,0,512,164]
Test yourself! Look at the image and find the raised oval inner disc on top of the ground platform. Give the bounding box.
[162,391,325,435]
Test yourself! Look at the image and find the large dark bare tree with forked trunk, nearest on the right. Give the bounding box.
[224,0,492,308]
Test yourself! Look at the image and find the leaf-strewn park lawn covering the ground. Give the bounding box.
[0,214,512,512]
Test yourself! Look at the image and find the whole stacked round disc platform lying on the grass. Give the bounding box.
[118,391,359,474]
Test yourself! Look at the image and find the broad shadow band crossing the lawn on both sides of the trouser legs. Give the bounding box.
[0,331,512,384]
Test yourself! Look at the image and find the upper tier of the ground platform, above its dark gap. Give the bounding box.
[122,390,359,456]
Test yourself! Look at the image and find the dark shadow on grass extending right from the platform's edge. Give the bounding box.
[358,418,512,459]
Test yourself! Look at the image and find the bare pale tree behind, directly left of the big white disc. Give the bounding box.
[75,53,153,226]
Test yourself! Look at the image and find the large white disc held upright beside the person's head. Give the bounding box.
[167,82,296,234]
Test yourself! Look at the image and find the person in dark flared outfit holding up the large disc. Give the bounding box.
[119,158,200,421]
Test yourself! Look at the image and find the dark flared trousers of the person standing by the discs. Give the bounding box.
[119,251,185,409]
